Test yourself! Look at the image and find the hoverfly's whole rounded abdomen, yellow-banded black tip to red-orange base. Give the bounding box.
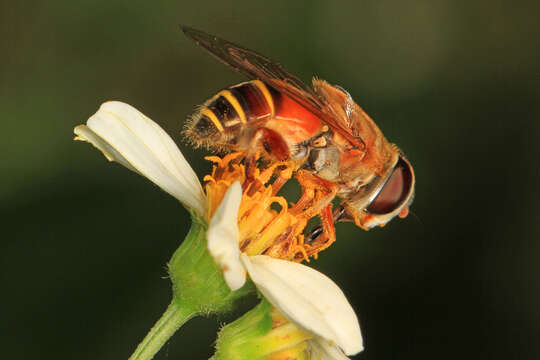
[184,80,322,156]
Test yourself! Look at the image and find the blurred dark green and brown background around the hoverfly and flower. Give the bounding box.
[0,0,540,360]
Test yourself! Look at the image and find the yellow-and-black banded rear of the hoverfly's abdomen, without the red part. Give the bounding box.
[185,80,279,147]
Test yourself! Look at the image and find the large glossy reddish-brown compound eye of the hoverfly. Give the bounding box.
[367,157,413,214]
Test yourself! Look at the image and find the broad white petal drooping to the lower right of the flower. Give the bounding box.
[241,254,363,355]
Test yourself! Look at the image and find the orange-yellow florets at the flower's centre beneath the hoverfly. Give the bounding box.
[204,152,323,261]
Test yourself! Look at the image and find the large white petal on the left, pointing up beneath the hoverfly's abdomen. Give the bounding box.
[75,101,205,215]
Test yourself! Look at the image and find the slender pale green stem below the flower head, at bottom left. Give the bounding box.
[129,300,198,360]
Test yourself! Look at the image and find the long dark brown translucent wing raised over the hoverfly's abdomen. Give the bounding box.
[182,26,364,148]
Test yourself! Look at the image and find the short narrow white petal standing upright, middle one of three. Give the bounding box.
[206,181,246,291]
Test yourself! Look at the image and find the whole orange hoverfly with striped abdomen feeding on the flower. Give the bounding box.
[182,26,415,249]
